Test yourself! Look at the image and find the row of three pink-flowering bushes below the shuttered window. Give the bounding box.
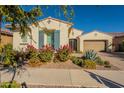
[27,45,72,62]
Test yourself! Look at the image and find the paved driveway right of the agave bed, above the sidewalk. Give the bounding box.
[98,52,124,70]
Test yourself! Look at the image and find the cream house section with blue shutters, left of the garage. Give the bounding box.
[13,17,82,51]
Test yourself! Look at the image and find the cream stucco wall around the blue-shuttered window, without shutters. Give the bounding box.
[13,19,71,49]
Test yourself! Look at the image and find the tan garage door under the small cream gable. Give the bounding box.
[84,40,106,51]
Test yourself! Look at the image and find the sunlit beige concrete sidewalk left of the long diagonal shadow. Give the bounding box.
[1,68,105,87]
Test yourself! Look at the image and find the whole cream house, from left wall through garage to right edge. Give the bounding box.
[13,17,124,52]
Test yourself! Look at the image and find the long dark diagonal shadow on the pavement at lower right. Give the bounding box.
[84,70,124,88]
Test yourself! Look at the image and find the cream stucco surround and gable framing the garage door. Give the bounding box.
[80,31,113,51]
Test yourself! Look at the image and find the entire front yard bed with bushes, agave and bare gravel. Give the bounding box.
[0,45,119,69]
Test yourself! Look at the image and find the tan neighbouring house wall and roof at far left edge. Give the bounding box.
[1,30,13,45]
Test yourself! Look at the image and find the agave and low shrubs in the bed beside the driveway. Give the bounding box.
[70,50,118,70]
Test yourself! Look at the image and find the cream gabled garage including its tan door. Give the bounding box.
[80,31,113,52]
